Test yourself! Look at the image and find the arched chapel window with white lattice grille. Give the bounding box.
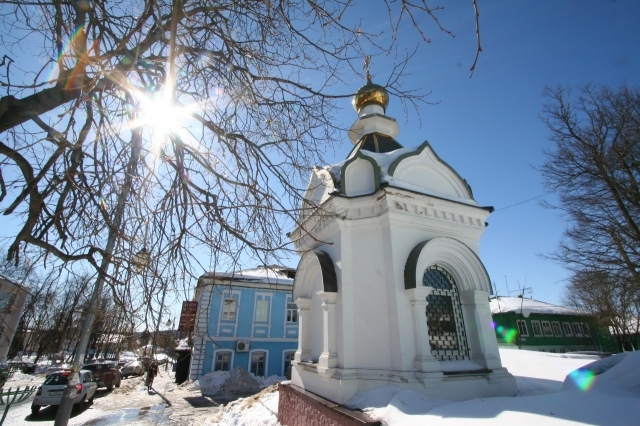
[422,265,469,361]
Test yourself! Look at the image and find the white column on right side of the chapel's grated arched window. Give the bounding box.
[460,290,502,370]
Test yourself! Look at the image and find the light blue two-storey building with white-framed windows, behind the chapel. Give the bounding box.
[190,267,298,380]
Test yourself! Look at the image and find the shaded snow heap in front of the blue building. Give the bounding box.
[194,367,263,395]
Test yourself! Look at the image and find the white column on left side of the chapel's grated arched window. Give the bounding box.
[406,286,440,373]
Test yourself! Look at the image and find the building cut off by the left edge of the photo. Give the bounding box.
[0,275,30,362]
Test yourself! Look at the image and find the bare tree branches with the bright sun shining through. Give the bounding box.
[0,0,480,280]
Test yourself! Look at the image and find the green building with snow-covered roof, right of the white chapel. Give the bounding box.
[490,296,614,353]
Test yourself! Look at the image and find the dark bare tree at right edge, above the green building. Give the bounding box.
[541,86,640,350]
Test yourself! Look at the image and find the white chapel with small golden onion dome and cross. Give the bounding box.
[290,76,517,404]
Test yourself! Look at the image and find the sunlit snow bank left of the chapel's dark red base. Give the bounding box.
[203,385,280,426]
